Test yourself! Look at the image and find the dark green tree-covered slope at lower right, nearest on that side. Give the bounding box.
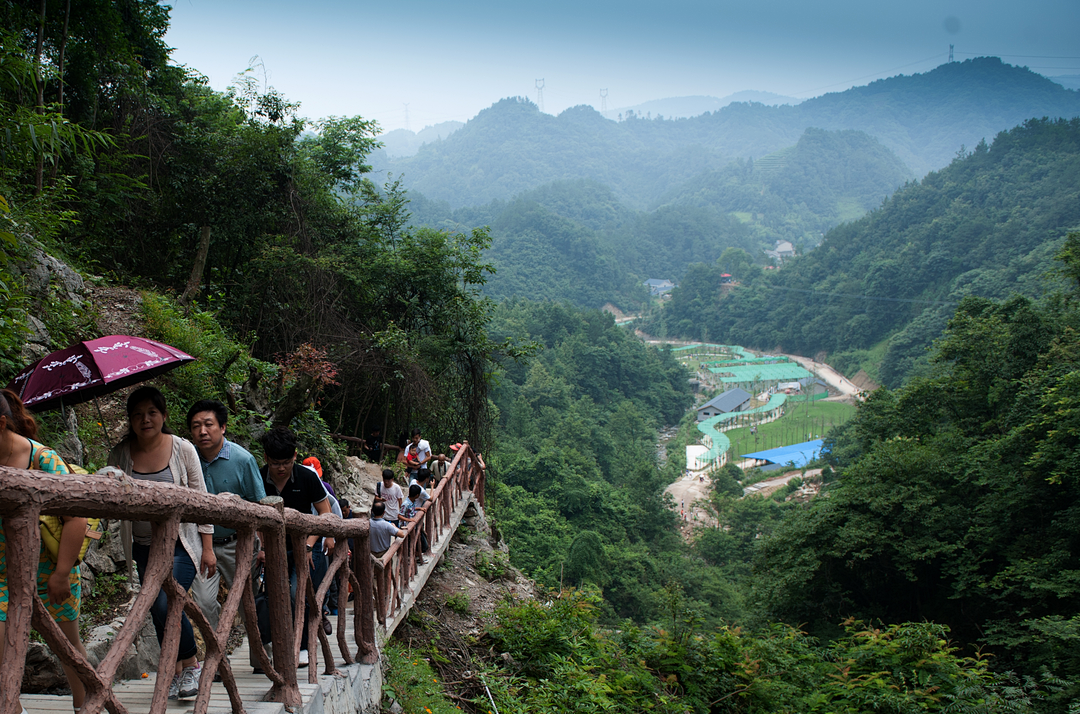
[755,241,1080,682]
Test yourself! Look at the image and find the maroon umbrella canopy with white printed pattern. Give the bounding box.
[8,335,194,412]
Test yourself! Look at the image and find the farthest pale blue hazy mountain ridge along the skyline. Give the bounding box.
[376,57,1080,208]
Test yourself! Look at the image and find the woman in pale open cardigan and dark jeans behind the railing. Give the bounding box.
[109,387,217,699]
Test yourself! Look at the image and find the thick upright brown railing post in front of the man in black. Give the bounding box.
[258,496,303,706]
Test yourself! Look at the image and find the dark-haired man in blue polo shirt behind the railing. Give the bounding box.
[188,400,267,629]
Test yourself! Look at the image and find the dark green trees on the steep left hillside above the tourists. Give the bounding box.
[0,1,513,451]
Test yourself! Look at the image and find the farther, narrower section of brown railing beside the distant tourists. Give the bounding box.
[375,442,486,627]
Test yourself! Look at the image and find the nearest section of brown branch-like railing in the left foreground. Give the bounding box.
[0,467,378,714]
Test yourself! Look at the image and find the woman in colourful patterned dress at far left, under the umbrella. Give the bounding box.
[0,389,86,712]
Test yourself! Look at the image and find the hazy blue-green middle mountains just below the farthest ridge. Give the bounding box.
[410,130,910,307]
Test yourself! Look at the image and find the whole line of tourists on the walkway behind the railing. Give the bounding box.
[0,387,447,714]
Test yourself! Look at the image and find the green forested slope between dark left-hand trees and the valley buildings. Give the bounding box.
[491,301,717,621]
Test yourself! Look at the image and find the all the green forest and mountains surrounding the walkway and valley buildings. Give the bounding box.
[0,0,1080,714]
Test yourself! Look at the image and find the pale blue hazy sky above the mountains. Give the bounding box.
[165,0,1080,131]
